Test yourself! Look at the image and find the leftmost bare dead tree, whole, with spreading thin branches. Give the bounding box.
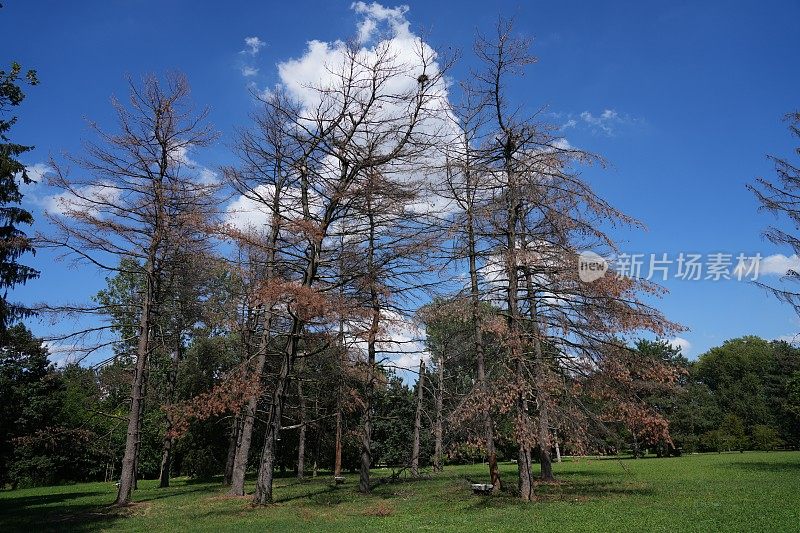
[40,74,216,505]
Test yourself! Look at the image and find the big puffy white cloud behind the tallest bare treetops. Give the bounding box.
[270,2,455,213]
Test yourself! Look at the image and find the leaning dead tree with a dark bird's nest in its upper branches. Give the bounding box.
[254,38,443,504]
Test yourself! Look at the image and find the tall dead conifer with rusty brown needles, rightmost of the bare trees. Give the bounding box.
[476,22,679,501]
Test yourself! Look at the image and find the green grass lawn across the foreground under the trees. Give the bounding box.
[0,452,800,533]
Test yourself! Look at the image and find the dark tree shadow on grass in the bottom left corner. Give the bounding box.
[0,491,125,532]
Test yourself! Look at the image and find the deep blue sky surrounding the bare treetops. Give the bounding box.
[6,0,800,357]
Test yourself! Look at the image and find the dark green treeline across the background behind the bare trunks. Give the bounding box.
[0,325,800,486]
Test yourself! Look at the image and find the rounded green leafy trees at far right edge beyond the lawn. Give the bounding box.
[662,336,800,452]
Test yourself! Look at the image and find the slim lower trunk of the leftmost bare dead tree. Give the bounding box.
[116,272,153,505]
